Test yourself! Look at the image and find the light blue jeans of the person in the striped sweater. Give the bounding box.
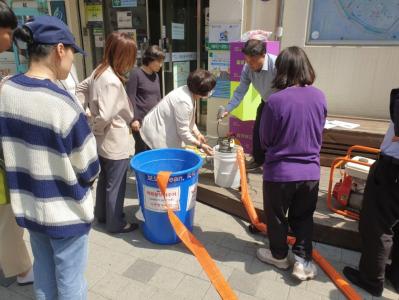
[29,230,88,300]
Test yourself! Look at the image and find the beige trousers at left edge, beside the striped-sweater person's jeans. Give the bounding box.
[0,204,32,277]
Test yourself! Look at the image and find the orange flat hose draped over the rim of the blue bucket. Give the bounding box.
[157,172,238,300]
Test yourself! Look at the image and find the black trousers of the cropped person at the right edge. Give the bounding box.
[359,160,399,288]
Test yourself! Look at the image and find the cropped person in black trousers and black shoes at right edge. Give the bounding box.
[343,122,399,297]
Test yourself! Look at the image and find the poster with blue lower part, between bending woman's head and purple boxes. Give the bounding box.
[208,44,230,98]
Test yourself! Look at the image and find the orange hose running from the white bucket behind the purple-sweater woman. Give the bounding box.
[237,147,362,300]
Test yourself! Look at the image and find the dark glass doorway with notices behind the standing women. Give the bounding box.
[80,0,209,96]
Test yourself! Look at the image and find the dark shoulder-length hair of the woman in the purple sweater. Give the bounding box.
[273,46,316,90]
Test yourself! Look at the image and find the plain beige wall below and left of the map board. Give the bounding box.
[282,0,399,118]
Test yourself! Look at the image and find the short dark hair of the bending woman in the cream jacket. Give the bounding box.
[187,69,216,97]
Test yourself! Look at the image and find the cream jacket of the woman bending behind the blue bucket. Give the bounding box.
[140,85,199,149]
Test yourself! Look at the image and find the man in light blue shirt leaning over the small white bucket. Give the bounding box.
[223,40,276,167]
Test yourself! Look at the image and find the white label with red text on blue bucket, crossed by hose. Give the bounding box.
[144,185,180,212]
